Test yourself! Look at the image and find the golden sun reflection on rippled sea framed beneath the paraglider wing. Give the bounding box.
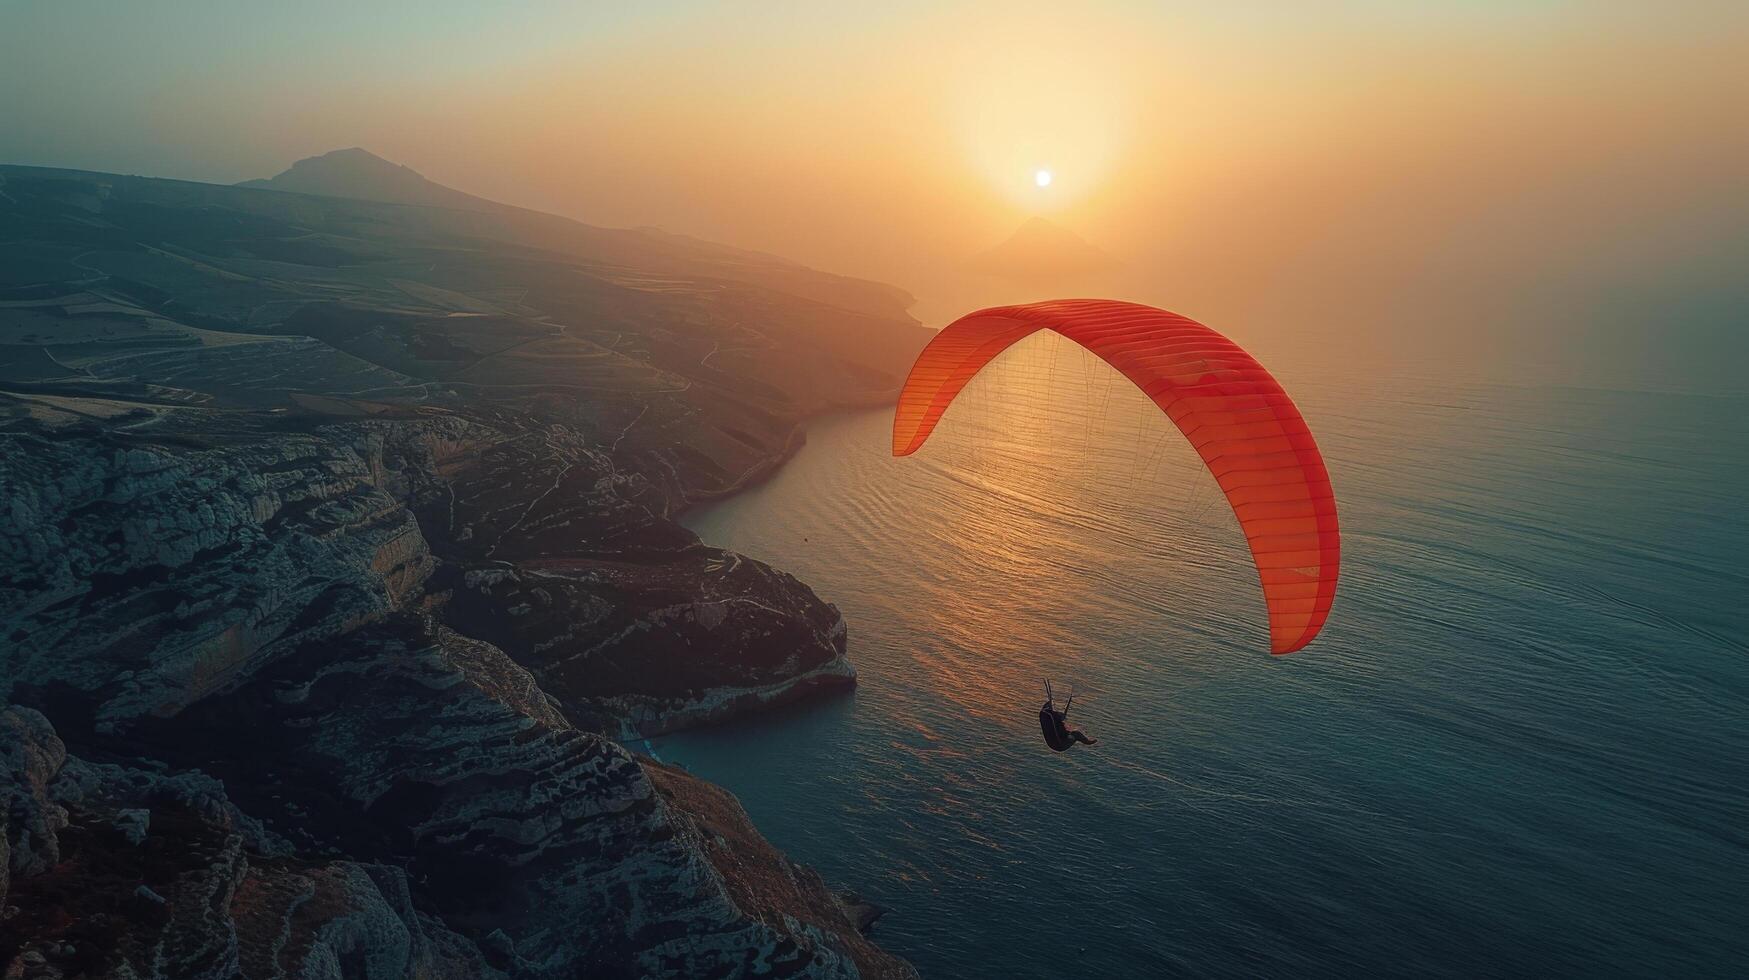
[867,333,1263,719]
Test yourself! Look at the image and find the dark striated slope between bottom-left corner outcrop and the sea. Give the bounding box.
[105,620,874,977]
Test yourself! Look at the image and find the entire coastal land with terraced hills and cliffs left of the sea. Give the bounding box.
[0,168,923,977]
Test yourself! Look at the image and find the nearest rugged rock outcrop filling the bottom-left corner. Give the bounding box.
[0,707,497,980]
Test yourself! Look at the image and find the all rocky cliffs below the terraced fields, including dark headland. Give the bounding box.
[0,413,908,978]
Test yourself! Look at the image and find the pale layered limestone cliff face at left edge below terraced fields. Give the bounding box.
[0,434,434,726]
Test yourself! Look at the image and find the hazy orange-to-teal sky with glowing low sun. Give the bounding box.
[0,0,1749,388]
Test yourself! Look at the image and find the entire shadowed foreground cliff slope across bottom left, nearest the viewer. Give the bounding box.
[10,614,909,978]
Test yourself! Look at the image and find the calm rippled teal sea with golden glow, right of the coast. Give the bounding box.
[654,336,1749,977]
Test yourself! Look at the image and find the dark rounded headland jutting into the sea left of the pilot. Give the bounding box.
[451,546,855,737]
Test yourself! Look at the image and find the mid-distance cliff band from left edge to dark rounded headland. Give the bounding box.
[0,413,854,733]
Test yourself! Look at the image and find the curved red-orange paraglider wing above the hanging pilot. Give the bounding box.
[892,299,1341,653]
